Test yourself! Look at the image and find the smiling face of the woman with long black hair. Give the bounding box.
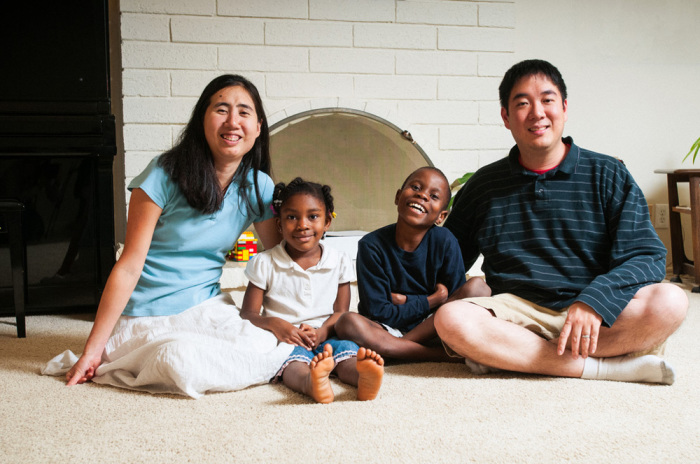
[204,85,261,167]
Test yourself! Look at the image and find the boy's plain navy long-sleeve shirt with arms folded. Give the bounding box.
[357,224,466,332]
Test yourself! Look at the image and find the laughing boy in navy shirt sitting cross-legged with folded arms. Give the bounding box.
[335,167,491,361]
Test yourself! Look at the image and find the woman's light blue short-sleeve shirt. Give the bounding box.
[122,157,274,316]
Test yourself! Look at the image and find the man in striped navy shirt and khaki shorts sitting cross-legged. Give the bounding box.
[435,60,688,384]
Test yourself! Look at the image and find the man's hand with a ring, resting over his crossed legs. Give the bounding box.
[557,301,603,359]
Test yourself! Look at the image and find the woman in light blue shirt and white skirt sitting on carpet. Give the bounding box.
[66,75,291,397]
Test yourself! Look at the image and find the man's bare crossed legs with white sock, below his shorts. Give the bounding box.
[434,283,688,384]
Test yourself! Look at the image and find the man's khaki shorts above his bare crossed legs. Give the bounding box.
[450,293,666,356]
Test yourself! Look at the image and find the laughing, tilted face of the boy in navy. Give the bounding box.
[394,169,450,228]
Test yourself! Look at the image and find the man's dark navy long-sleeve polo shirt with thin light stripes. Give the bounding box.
[445,138,666,326]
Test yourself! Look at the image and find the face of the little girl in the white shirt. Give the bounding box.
[277,193,331,261]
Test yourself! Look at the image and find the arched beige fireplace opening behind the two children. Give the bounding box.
[270,108,433,258]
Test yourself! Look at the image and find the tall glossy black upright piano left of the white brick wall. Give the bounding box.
[0,0,116,316]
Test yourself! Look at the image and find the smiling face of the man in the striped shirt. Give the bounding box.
[501,74,568,154]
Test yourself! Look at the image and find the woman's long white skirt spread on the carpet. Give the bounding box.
[44,293,293,398]
